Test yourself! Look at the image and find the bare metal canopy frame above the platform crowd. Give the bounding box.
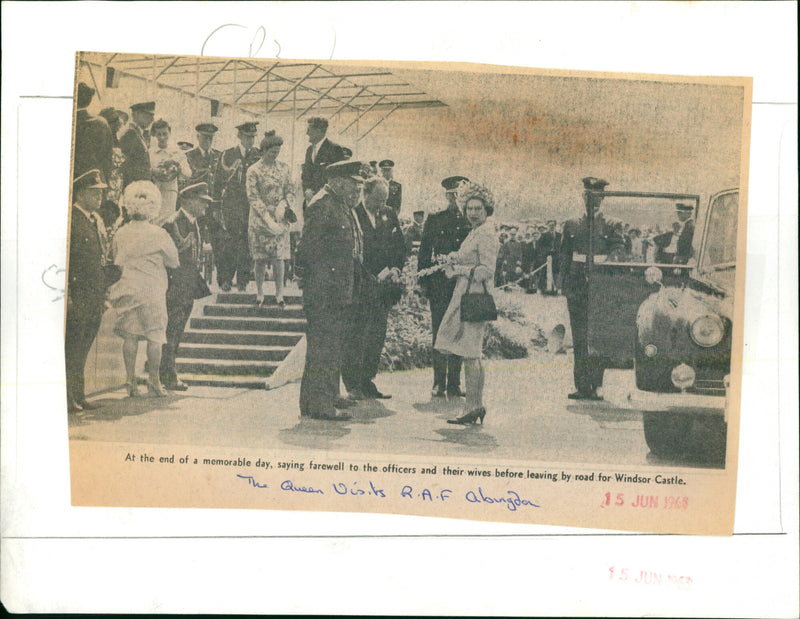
[80,52,447,142]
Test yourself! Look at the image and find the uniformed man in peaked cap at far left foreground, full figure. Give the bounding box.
[64,170,107,413]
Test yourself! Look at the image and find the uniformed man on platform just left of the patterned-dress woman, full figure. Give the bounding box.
[214,122,261,292]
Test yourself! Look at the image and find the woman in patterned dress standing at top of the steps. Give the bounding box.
[246,131,294,307]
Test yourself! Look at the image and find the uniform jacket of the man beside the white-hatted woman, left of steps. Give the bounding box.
[163,210,211,305]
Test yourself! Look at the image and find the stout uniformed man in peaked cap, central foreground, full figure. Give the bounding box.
[295,161,364,419]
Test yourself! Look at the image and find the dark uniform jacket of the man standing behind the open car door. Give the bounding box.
[558,215,612,295]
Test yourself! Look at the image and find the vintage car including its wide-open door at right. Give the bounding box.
[586,189,739,460]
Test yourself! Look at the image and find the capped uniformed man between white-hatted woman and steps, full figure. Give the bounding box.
[159,183,212,391]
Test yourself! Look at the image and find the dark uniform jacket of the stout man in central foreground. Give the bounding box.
[295,186,358,307]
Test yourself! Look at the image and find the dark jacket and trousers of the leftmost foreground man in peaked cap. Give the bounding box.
[64,207,106,404]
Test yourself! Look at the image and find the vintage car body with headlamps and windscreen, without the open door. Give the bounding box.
[631,189,739,460]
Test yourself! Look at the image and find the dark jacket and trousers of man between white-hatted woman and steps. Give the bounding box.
[160,210,211,385]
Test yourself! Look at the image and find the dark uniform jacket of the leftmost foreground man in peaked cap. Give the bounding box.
[67,207,106,309]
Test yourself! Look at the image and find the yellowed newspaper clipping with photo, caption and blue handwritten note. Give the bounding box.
[65,52,751,531]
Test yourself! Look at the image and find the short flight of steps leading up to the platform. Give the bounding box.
[175,292,306,389]
